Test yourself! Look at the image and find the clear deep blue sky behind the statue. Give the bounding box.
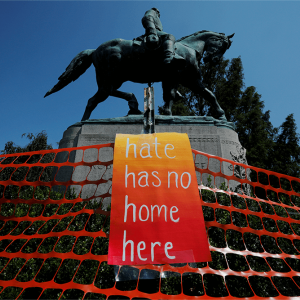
[0,1,300,150]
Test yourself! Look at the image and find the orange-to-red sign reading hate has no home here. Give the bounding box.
[108,133,211,265]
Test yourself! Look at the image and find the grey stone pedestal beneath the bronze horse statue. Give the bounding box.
[59,115,246,187]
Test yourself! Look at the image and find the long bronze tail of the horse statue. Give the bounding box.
[44,49,95,98]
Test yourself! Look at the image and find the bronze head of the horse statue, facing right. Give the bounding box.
[203,32,234,64]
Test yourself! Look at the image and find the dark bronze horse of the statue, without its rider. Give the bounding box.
[44,30,234,121]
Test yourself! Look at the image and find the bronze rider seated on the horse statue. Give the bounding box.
[142,7,185,67]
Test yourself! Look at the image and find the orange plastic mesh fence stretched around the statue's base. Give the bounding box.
[0,144,300,299]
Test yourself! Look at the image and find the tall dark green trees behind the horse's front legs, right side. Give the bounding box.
[159,57,300,177]
